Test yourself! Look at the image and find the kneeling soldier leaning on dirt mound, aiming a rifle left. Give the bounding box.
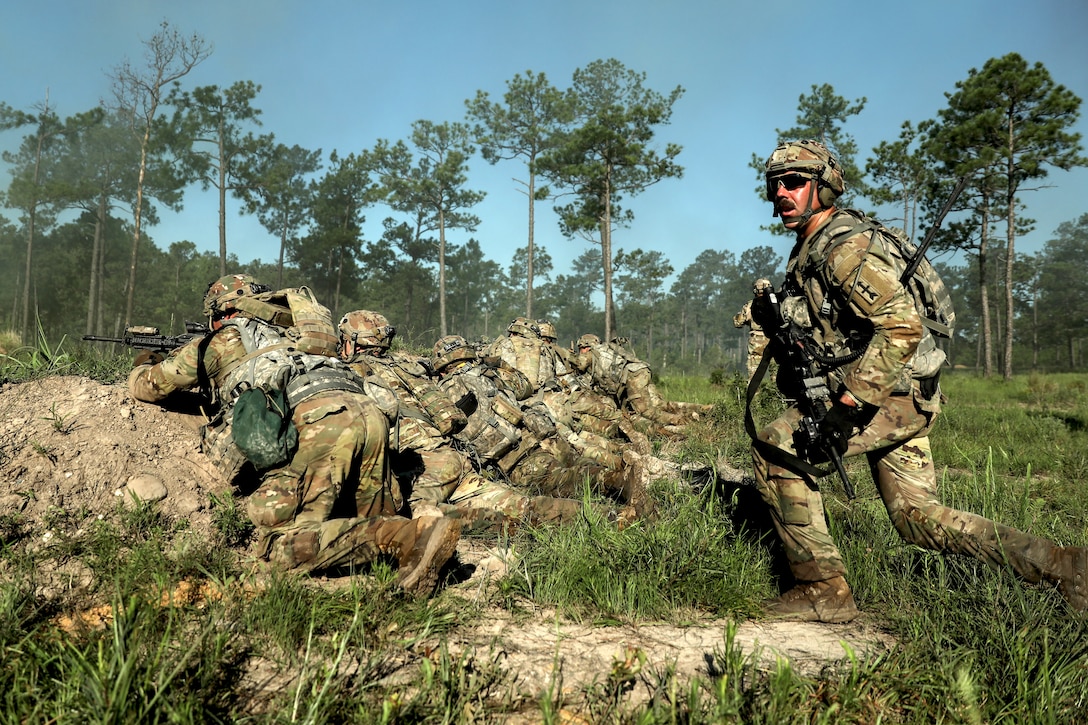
[128,274,460,593]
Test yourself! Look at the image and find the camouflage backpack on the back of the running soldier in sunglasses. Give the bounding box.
[828,209,955,339]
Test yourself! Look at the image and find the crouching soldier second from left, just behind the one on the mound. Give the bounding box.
[338,310,581,528]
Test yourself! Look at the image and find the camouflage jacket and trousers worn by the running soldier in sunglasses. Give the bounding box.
[752,205,1054,581]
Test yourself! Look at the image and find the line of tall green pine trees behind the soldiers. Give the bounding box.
[0,23,1088,377]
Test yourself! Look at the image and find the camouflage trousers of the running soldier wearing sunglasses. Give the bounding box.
[752,395,1054,581]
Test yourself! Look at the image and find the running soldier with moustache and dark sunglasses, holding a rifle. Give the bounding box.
[752,140,1088,622]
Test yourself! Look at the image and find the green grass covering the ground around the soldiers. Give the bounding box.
[6,337,1088,724]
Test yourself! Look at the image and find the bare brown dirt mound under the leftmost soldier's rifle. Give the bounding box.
[0,377,230,536]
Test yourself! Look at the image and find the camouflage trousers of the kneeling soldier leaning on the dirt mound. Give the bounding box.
[247,391,398,570]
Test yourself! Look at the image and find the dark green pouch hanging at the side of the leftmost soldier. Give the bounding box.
[231,388,298,470]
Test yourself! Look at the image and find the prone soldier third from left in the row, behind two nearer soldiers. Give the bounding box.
[431,335,646,512]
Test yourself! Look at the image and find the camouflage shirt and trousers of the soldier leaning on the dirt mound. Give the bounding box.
[128,275,458,592]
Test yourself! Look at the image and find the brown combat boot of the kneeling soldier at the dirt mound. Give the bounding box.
[375,516,461,597]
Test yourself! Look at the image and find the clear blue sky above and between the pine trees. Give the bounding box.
[0,0,1088,283]
